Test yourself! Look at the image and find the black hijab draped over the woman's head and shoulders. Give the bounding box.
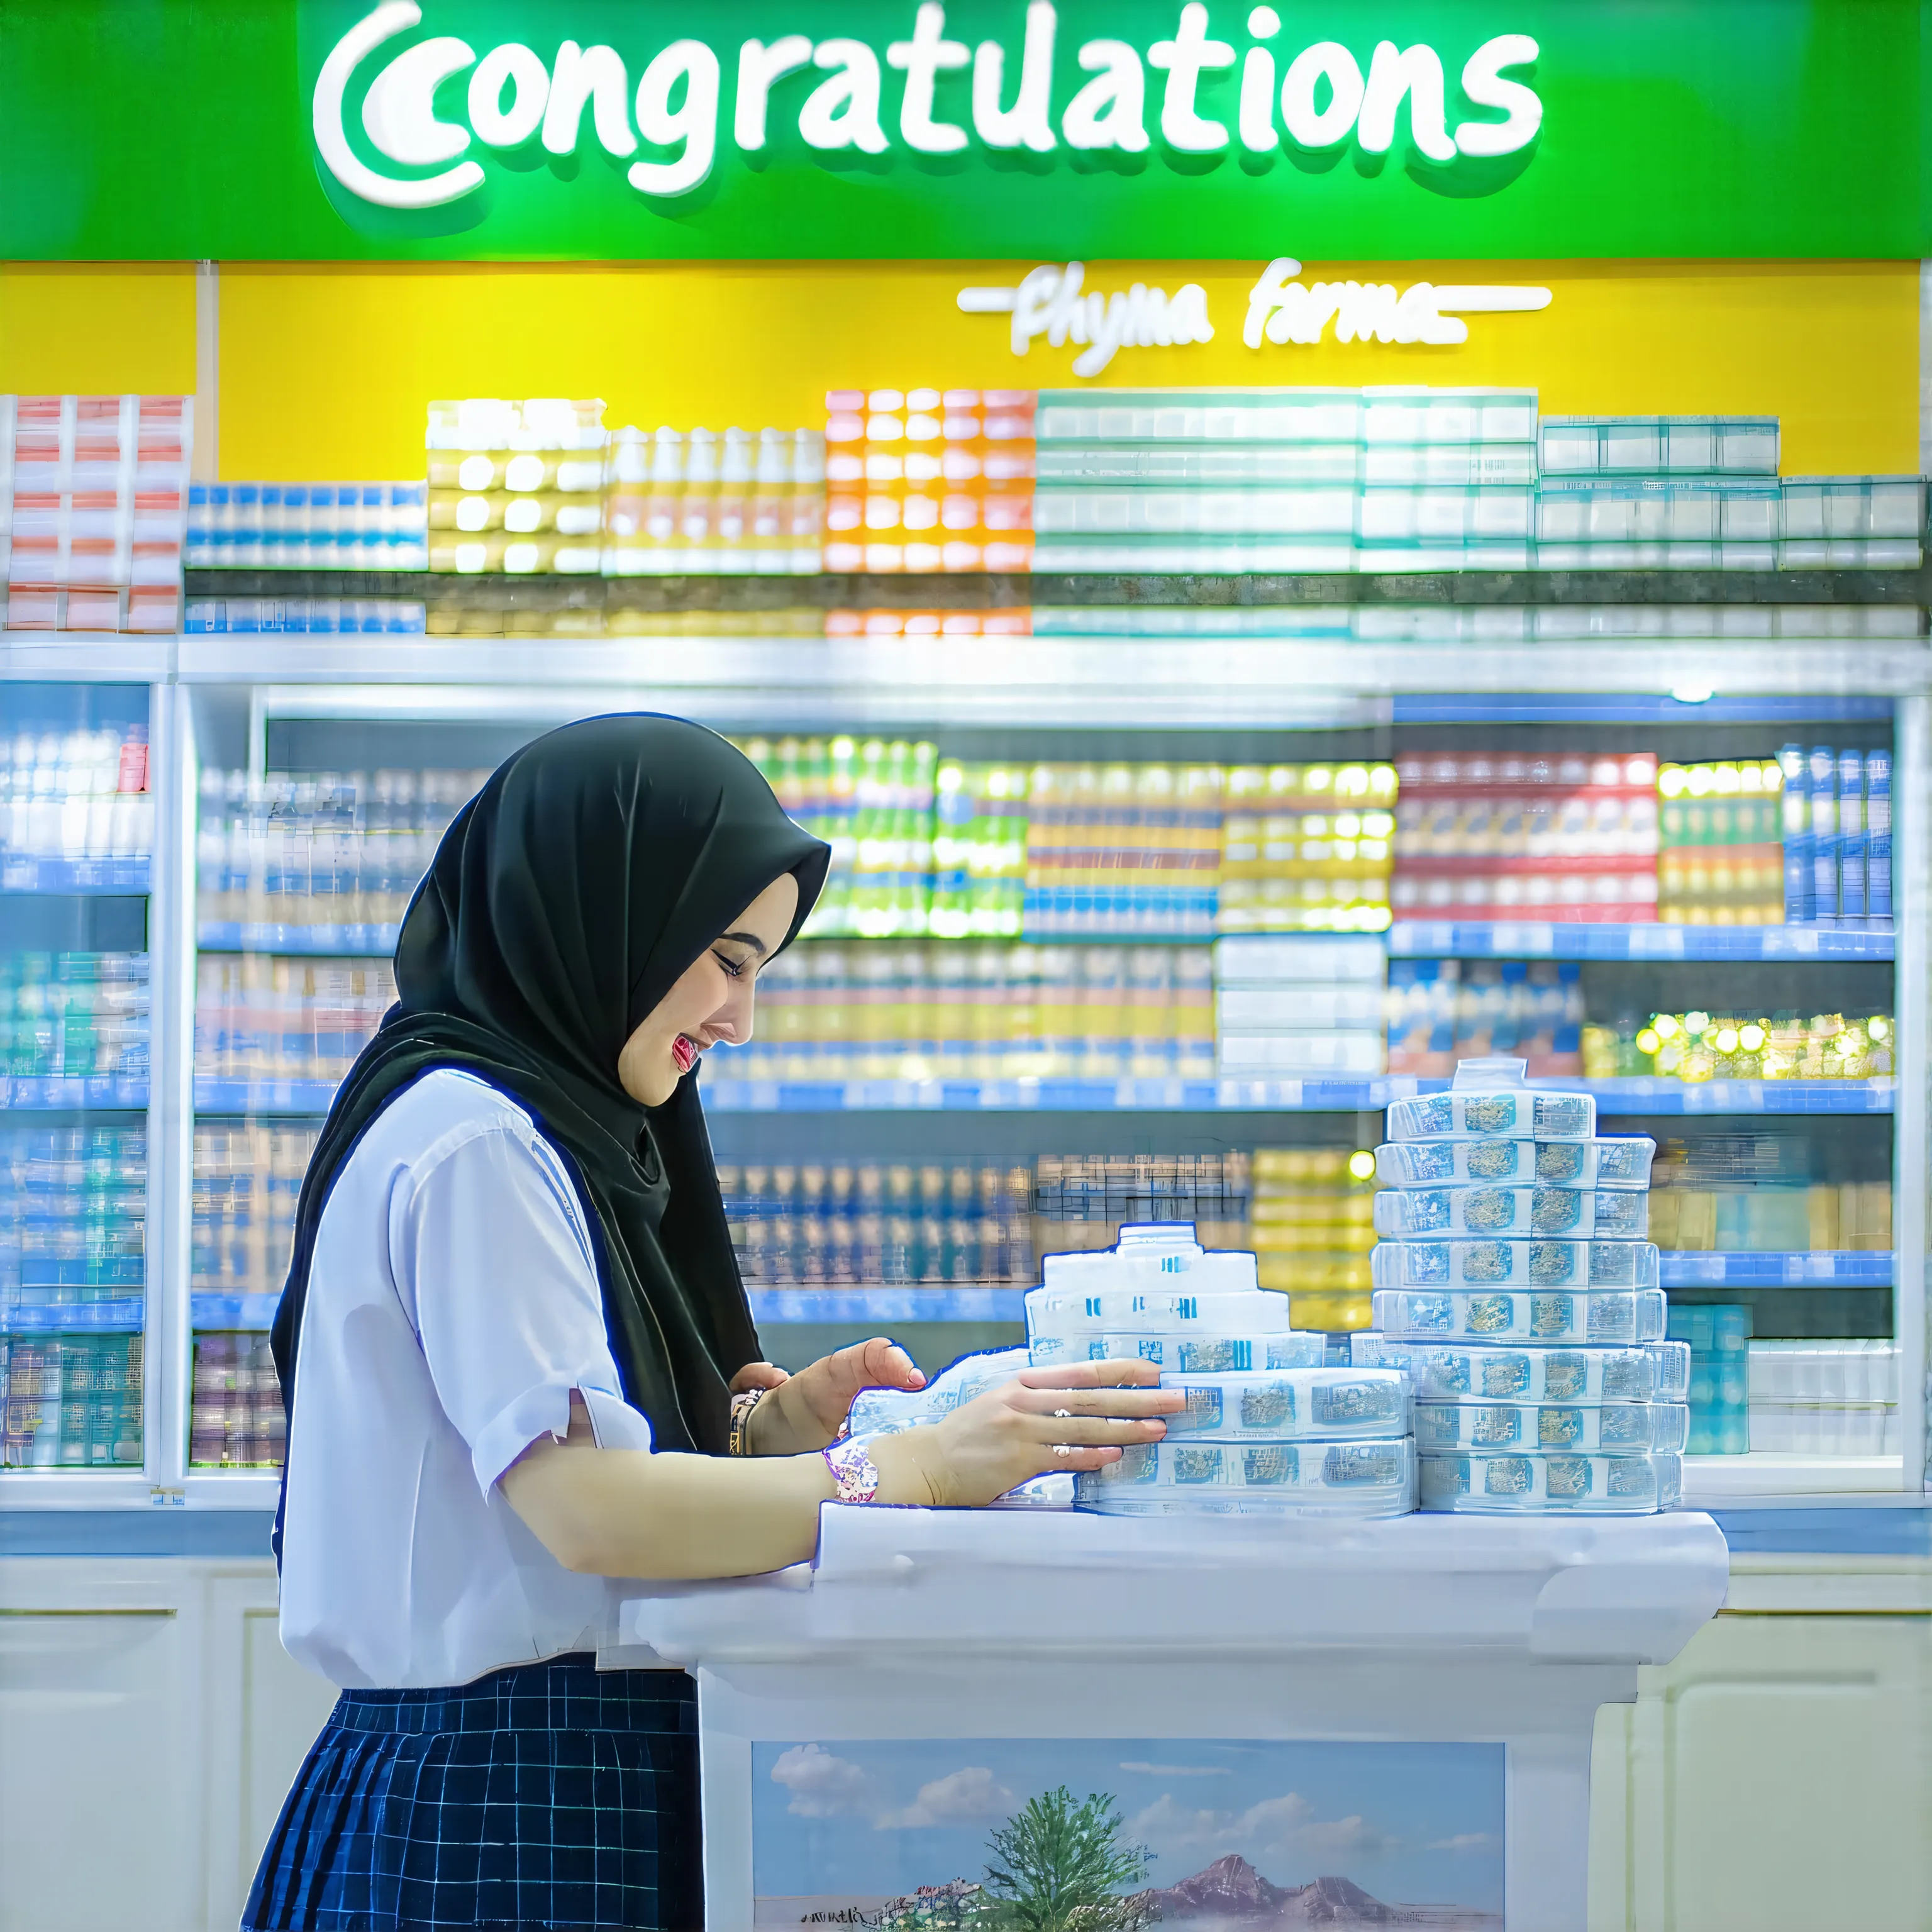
[272,713,831,1507]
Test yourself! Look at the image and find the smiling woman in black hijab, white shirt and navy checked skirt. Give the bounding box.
[243,717,1180,1932]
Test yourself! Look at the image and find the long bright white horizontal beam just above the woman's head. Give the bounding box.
[180,636,1932,730]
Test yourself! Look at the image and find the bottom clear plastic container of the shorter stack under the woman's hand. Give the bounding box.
[1074,1435,1416,1517]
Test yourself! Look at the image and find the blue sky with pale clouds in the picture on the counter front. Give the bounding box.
[752,1739,1503,1913]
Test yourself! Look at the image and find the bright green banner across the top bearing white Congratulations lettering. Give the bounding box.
[0,0,1932,261]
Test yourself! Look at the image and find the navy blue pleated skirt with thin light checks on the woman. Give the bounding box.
[242,1654,705,1932]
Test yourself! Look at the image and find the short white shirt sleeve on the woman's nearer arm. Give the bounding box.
[388,1113,651,1494]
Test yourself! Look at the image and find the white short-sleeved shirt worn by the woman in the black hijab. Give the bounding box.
[282,1069,651,1689]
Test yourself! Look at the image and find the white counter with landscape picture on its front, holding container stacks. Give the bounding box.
[605,1505,1727,1932]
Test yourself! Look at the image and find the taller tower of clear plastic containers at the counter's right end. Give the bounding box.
[1354,1058,1689,1514]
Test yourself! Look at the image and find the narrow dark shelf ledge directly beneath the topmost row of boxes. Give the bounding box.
[186,566,1932,611]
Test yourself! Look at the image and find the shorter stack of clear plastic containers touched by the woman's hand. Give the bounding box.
[1026,1221,1416,1517]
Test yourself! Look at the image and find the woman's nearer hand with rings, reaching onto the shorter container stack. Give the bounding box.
[871,1362,1186,1509]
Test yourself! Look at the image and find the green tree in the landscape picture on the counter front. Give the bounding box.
[980,1785,1152,1932]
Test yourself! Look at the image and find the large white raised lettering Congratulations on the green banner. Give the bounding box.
[313,0,1544,209]
